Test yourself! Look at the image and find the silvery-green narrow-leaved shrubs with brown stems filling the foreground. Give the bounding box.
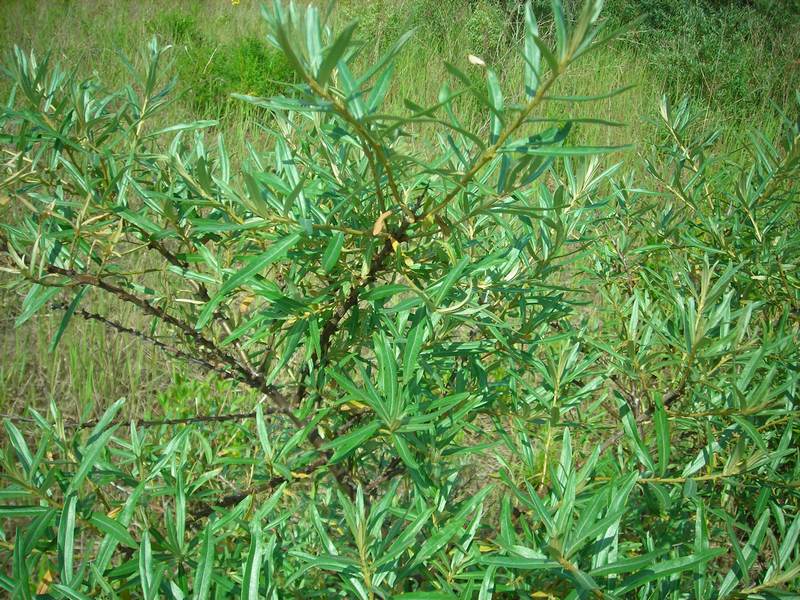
[0,0,800,600]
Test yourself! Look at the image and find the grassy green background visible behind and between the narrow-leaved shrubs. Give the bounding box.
[0,0,800,416]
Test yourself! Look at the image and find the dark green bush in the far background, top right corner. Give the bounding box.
[608,0,800,112]
